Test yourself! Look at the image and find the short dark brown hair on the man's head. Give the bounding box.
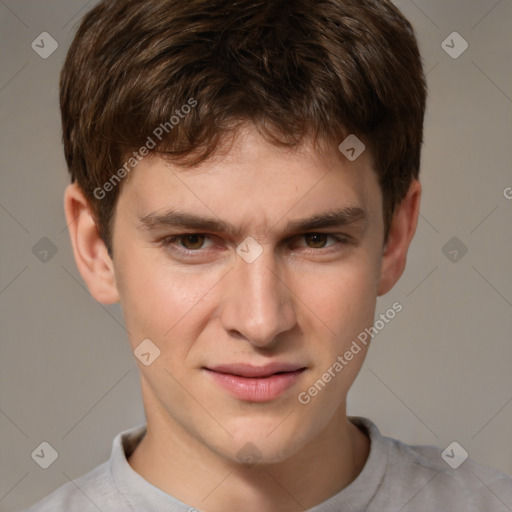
[60,0,426,250]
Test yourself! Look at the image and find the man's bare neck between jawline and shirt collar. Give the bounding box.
[128,392,369,512]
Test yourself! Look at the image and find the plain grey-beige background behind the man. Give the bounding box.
[0,0,512,511]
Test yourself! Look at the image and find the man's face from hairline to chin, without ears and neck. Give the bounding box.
[113,127,384,462]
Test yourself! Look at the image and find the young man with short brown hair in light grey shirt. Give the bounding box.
[26,0,512,512]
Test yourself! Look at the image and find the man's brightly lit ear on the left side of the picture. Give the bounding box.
[64,183,119,304]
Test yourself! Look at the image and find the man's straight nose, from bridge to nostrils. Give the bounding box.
[221,250,297,348]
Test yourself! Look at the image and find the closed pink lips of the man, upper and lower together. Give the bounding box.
[204,363,306,402]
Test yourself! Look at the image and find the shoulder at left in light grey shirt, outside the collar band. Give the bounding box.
[21,462,131,512]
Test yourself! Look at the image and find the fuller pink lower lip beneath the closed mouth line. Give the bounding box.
[207,370,304,402]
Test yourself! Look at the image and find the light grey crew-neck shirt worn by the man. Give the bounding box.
[22,417,512,512]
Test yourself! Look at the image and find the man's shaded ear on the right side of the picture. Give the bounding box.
[377,180,421,296]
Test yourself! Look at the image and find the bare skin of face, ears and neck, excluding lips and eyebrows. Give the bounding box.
[65,125,421,512]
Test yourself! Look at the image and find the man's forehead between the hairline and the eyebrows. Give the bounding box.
[119,127,381,234]
